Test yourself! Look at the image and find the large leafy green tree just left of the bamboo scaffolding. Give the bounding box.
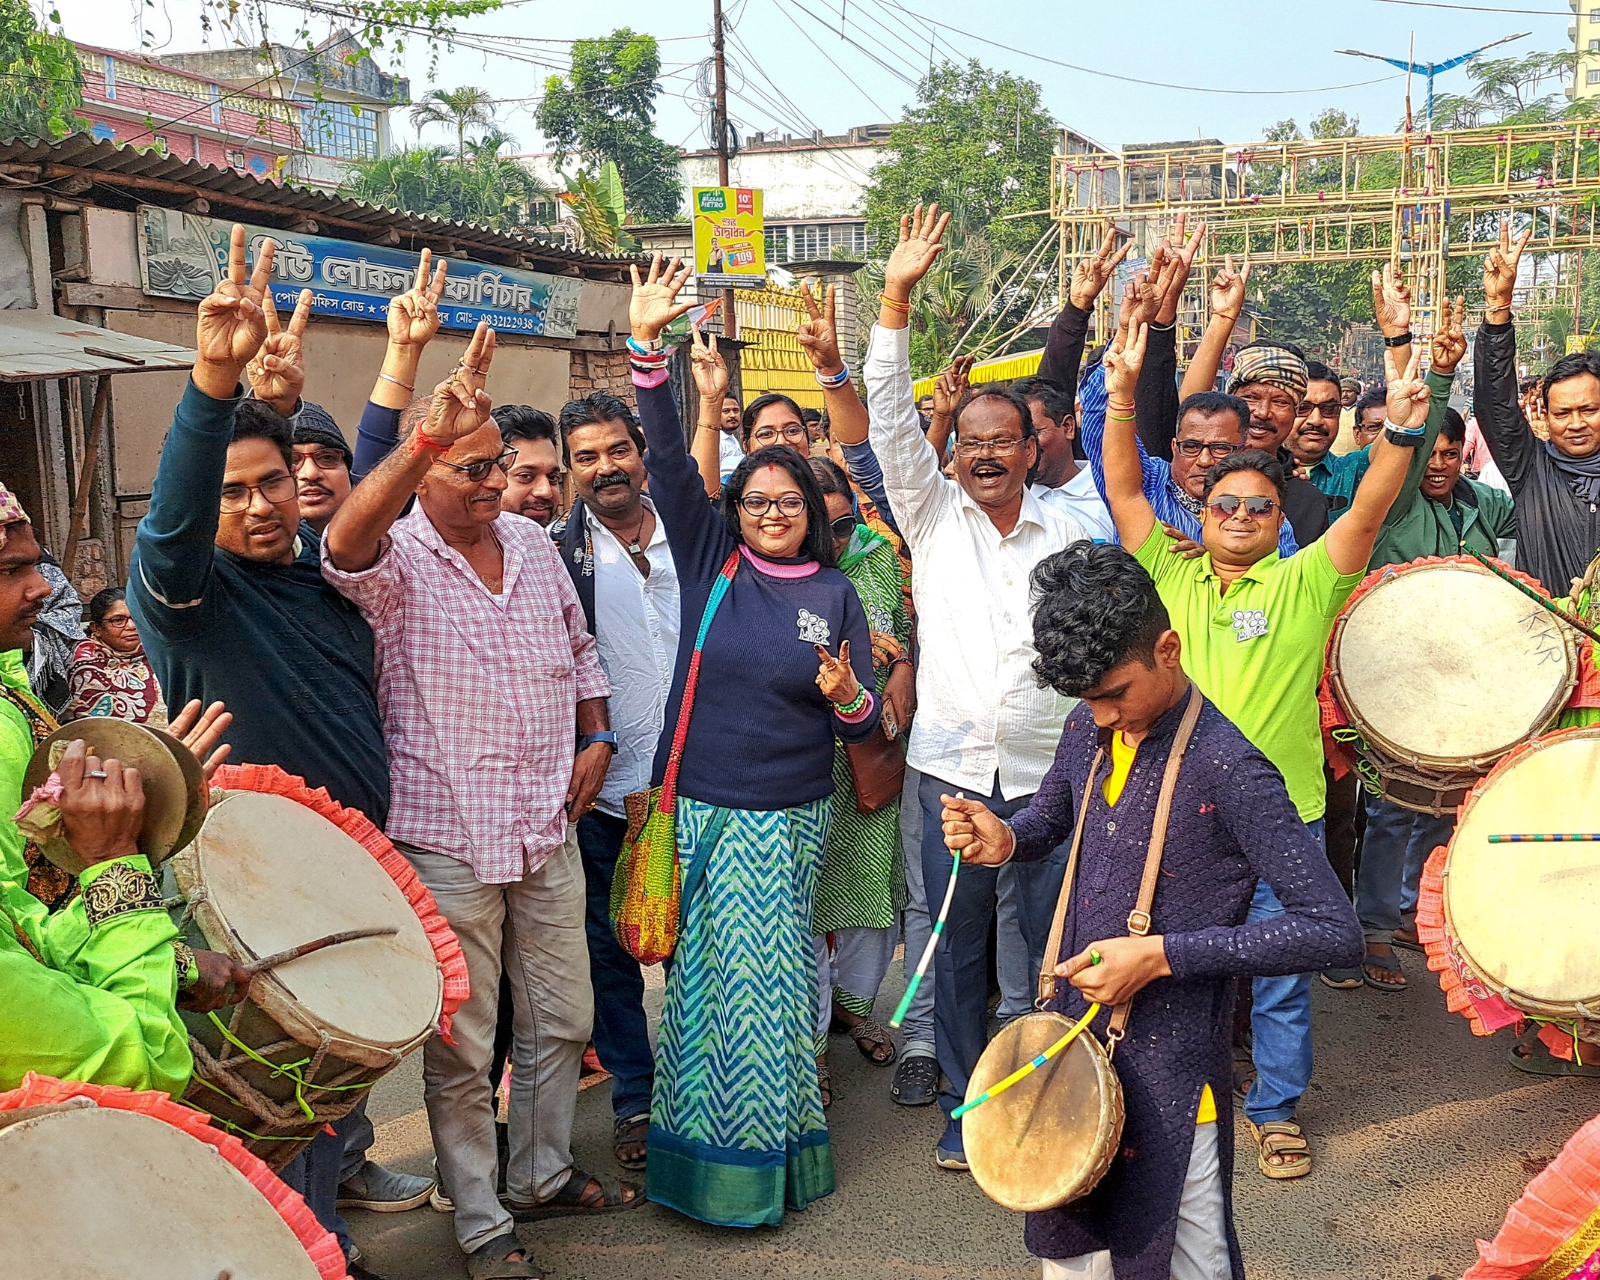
[867,61,1059,251]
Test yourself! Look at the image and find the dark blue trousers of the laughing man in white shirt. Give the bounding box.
[918,773,1067,1136]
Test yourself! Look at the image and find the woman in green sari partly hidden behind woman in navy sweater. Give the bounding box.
[811,458,915,1106]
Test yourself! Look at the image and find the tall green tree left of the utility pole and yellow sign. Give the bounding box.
[534,27,683,222]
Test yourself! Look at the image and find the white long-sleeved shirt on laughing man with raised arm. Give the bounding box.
[864,326,1090,800]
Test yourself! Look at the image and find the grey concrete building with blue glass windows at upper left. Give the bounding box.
[160,30,411,190]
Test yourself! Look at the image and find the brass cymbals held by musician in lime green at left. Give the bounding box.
[22,715,210,875]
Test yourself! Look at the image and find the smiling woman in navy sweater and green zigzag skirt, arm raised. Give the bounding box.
[629,256,878,1227]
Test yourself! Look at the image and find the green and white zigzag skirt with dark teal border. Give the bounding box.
[645,797,834,1227]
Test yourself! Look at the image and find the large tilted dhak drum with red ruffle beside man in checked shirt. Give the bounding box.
[171,771,451,1168]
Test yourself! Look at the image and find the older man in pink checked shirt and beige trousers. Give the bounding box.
[323,325,643,1277]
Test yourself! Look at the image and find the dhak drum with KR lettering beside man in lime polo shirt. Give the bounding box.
[1328,557,1578,814]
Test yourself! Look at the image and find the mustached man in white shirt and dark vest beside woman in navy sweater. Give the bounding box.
[550,392,678,1170]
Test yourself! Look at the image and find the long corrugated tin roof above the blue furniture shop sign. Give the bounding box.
[0,133,637,278]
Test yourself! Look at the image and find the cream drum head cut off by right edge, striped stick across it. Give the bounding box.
[1445,730,1600,1018]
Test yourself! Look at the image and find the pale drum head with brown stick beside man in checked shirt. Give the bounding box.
[186,792,443,1049]
